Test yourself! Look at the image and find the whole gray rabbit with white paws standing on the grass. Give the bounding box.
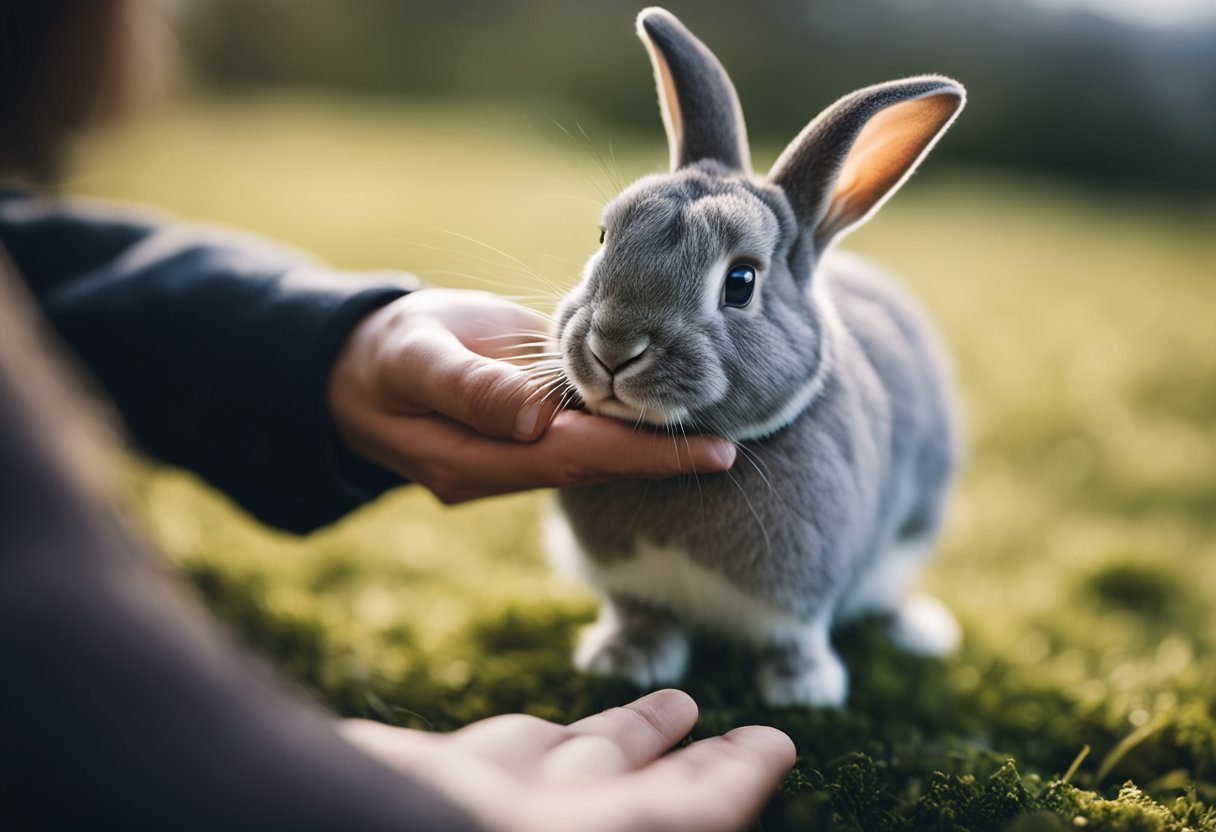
[548,9,964,707]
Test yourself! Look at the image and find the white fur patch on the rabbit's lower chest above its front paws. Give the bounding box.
[545,511,806,643]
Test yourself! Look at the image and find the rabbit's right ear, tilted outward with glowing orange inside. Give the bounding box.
[769,75,967,251]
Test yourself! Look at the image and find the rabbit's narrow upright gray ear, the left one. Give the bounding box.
[637,6,751,173]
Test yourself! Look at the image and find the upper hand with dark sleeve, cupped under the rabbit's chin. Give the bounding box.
[326,288,734,504]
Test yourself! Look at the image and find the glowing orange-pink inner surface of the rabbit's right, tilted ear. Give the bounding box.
[820,92,958,235]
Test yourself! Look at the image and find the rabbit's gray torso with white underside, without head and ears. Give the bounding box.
[548,252,956,698]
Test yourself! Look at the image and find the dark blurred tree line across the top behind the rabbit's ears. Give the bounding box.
[184,0,1216,195]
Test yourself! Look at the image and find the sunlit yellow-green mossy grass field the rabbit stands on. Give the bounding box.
[73,97,1216,832]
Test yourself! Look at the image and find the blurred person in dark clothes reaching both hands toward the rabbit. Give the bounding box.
[0,0,794,830]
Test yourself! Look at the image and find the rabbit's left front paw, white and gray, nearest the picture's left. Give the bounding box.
[574,608,688,688]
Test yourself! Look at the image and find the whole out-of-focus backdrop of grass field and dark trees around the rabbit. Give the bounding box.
[68,0,1216,830]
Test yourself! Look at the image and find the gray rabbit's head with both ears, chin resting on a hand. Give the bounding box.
[558,9,964,439]
